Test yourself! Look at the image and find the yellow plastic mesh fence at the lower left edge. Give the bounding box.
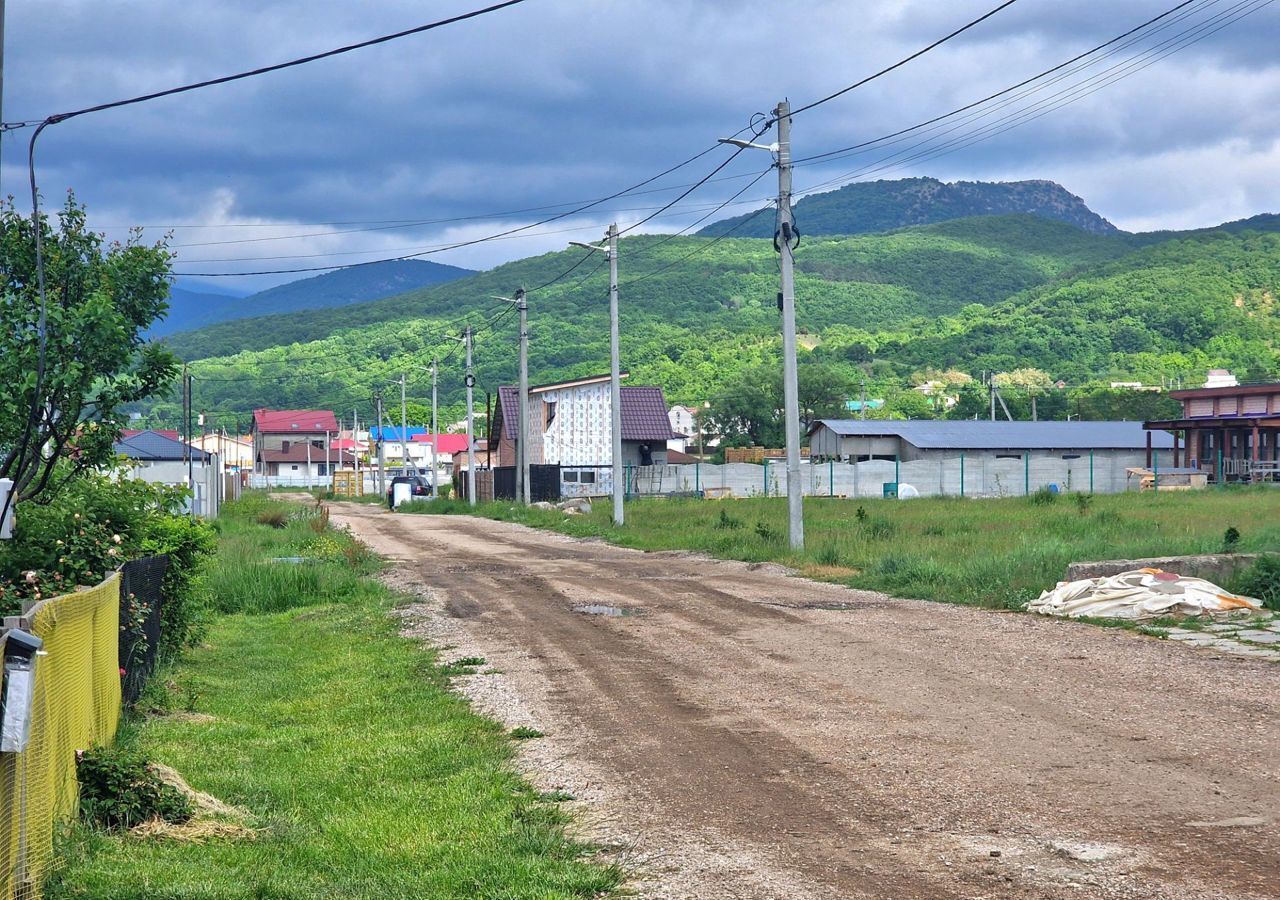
[0,575,120,900]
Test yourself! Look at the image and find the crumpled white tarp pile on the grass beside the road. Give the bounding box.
[1027,568,1262,618]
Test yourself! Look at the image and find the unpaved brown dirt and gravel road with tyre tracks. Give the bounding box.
[334,503,1280,899]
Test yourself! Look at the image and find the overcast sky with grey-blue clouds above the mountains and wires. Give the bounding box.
[0,0,1280,288]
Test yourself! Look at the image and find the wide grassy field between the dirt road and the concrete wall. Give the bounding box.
[406,486,1280,609]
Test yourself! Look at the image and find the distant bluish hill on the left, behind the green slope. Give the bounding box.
[150,260,475,338]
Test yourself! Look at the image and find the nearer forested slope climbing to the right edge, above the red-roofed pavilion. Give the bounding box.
[855,230,1280,383]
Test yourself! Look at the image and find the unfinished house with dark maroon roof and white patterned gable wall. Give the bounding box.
[489,375,673,495]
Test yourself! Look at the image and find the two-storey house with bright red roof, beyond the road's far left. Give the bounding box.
[253,410,356,480]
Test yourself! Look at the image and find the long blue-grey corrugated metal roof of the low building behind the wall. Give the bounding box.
[809,419,1174,451]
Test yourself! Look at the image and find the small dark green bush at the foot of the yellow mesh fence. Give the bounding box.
[76,748,196,830]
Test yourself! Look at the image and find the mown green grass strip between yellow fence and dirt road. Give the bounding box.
[47,495,620,900]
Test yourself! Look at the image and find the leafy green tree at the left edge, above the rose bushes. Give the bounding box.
[0,195,177,499]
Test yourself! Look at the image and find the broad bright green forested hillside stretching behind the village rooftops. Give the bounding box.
[137,216,1280,435]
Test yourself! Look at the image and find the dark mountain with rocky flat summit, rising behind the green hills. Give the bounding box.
[698,178,1119,238]
